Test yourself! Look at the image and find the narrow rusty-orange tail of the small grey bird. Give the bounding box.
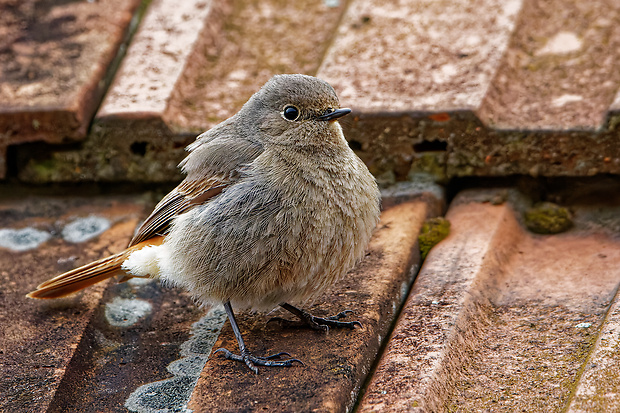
[26,236,164,298]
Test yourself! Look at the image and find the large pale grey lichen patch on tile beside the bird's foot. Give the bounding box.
[125,307,226,413]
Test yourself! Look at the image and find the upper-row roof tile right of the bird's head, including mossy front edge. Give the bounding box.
[318,0,620,183]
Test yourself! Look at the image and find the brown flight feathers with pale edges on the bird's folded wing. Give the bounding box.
[129,178,230,247]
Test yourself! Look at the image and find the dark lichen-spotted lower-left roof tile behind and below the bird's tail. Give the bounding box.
[0,196,230,412]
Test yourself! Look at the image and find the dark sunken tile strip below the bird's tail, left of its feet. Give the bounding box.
[48,262,211,413]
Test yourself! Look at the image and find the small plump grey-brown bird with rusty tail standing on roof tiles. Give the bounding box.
[28,74,380,373]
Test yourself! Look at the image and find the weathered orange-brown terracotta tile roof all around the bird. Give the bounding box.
[0,0,620,412]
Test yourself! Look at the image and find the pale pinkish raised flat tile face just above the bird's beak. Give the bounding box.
[318,0,521,114]
